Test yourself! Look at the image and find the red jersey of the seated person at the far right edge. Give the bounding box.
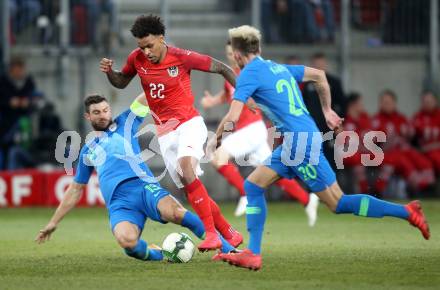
[413,109,440,151]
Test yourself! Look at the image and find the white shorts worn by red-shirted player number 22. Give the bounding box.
[158,116,208,188]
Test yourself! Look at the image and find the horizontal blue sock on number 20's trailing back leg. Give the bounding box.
[336,194,409,219]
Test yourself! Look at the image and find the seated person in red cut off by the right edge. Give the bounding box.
[413,91,440,175]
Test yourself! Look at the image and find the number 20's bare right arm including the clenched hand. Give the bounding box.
[303,67,344,130]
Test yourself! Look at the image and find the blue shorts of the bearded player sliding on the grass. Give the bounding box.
[107,178,170,231]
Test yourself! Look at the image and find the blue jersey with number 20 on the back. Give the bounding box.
[234,56,319,133]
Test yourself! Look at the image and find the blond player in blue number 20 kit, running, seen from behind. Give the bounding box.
[213,25,430,270]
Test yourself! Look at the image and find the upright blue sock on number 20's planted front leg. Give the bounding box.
[244,180,267,254]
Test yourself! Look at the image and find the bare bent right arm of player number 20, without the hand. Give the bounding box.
[303,67,332,112]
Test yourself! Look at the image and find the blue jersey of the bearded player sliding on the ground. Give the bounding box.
[74,110,155,205]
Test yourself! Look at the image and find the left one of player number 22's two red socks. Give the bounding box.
[185,179,215,233]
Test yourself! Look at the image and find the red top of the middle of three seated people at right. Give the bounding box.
[372,112,414,149]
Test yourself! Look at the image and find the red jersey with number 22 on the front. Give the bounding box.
[122,46,212,136]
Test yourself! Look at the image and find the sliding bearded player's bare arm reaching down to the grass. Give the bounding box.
[35,182,85,244]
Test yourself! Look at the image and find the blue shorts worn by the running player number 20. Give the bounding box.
[264,145,336,192]
